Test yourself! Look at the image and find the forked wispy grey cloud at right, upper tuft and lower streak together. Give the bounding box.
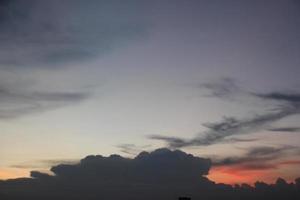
[149,79,300,148]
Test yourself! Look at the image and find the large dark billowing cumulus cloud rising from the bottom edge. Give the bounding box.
[0,149,213,199]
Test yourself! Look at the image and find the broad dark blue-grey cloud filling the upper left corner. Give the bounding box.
[0,0,146,68]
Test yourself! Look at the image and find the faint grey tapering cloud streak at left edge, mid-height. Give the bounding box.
[0,86,90,119]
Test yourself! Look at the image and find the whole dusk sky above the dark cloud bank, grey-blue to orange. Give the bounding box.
[0,0,300,183]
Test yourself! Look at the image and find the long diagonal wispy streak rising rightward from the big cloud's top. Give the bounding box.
[150,106,299,148]
